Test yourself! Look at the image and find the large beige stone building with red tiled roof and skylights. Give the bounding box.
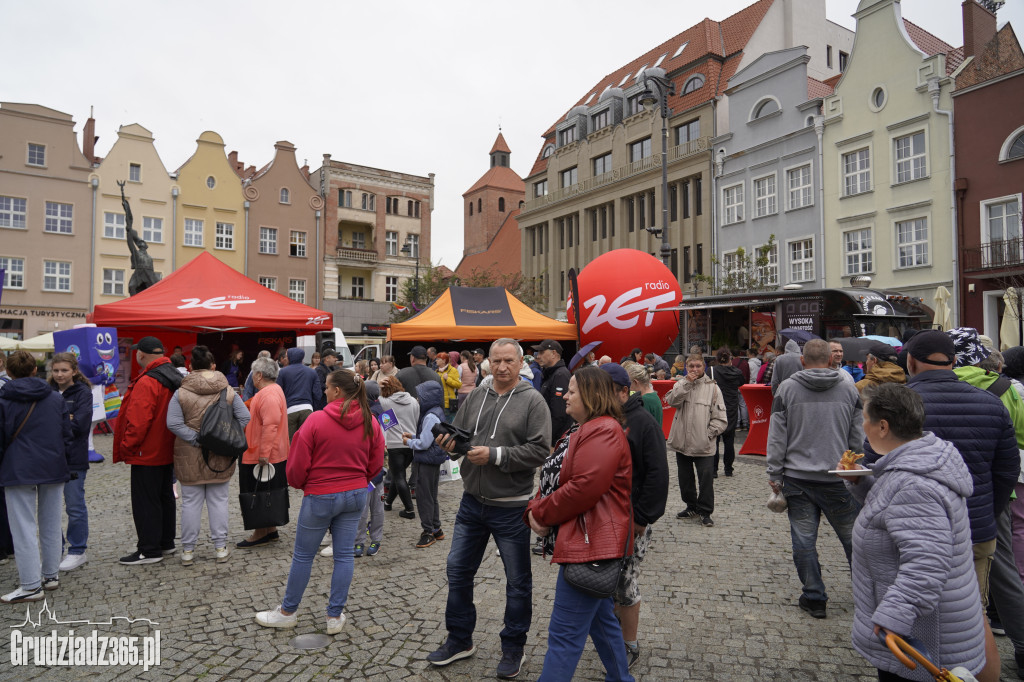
[518,0,852,316]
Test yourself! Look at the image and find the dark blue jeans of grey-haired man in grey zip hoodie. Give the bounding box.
[444,493,534,651]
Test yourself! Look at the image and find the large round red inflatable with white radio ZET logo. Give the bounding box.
[567,249,682,361]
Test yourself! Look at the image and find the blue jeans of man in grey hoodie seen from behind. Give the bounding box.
[782,476,860,601]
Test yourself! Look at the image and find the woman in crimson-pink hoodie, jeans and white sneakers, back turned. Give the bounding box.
[256,370,384,635]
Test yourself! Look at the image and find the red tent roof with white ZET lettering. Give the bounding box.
[91,251,334,334]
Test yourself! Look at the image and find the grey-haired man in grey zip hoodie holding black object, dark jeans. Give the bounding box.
[427,339,551,679]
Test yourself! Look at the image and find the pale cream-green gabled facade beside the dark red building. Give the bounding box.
[822,0,963,322]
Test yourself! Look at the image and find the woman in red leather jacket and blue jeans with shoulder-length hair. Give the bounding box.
[526,367,633,682]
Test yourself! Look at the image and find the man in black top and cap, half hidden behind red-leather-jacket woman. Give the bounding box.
[601,363,669,667]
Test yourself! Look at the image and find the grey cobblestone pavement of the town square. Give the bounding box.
[0,436,1016,682]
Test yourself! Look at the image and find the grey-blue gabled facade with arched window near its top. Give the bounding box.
[714,46,830,288]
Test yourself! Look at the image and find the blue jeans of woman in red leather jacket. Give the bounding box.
[538,566,633,682]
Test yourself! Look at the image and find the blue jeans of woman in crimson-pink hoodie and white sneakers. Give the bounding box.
[281,487,367,617]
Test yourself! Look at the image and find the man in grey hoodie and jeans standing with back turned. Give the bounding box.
[767,339,864,619]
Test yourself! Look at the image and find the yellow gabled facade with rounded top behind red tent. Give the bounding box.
[174,130,247,272]
